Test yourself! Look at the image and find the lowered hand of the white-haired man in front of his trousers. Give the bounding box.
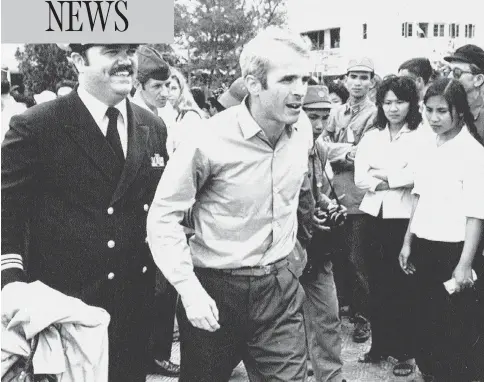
[182,289,220,332]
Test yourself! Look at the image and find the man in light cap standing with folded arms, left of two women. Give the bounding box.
[327,58,376,342]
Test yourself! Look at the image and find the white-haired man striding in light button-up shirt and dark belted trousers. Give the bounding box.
[148,28,311,382]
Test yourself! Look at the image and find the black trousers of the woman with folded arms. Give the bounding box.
[365,216,415,360]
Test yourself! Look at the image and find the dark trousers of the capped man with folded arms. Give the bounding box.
[334,214,370,318]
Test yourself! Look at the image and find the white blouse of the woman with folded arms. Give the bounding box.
[355,124,430,219]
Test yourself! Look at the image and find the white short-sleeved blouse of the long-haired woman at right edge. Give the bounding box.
[411,126,484,242]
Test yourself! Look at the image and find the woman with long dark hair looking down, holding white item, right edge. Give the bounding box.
[399,78,484,382]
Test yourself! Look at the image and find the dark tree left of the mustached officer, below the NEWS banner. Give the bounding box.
[15,44,77,94]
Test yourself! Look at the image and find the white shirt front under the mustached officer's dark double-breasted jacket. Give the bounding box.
[77,86,128,157]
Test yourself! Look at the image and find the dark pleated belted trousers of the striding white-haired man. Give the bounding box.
[178,266,307,382]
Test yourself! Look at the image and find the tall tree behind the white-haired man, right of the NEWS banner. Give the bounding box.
[175,0,285,87]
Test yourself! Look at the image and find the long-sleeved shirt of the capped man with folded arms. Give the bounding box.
[327,97,377,214]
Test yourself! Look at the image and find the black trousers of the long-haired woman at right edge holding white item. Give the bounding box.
[410,238,479,382]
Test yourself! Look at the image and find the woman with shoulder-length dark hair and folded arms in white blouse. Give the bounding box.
[355,77,426,376]
